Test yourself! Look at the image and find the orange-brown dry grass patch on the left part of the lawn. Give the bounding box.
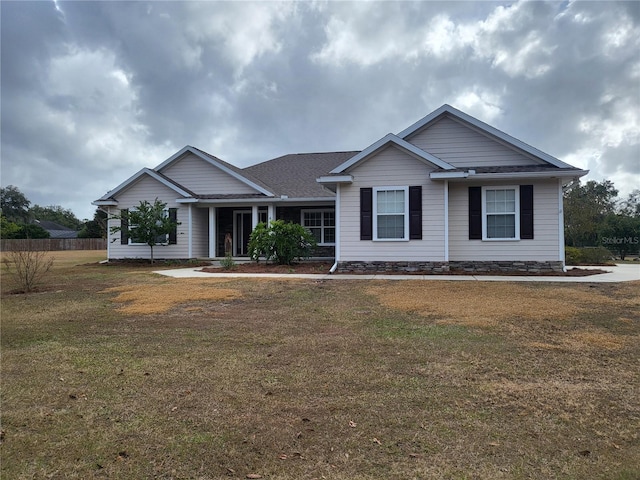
[102,280,242,315]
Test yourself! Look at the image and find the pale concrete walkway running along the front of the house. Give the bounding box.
[153,264,640,283]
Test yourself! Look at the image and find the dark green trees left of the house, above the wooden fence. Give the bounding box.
[0,185,107,239]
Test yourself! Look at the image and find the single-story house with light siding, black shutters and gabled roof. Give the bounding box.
[93,105,588,271]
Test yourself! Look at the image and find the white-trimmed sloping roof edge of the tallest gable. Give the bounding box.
[398,104,572,168]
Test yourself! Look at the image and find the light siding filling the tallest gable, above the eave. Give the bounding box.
[407,117,543,167]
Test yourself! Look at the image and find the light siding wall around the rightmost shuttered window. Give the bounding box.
[449,180,559,261]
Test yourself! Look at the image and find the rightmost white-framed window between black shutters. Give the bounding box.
[482,187,520,240]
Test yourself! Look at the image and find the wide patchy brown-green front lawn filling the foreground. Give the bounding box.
[0,253,640,480]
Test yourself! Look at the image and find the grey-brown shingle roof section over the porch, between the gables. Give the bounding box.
[241,151,359,198]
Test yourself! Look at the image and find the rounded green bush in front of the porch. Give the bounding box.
[249,220,316,265]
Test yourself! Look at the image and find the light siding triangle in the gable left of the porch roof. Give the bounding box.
[162,154,256,195]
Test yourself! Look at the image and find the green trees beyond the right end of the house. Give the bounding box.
[564,180,640,260]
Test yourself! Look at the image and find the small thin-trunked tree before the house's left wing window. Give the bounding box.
[110,198,180,264]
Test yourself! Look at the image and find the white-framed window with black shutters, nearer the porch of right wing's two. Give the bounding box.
[373,187,409,240]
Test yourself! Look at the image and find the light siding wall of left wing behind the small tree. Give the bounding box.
[109,175,189,259]
